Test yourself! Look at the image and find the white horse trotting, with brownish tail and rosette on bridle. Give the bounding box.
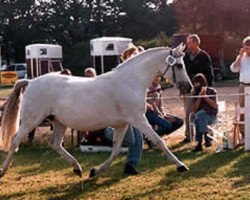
[0,45,192,177]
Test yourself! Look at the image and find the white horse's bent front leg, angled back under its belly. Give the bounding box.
[89,125,128,178]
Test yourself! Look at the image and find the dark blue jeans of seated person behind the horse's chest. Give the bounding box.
[146,111,183,136]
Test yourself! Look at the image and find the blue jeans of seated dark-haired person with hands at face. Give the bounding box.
[194,110,216,143]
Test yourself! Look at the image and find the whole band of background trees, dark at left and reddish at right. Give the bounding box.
[0,0,250,73]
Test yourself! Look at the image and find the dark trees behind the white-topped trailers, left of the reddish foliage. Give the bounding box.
[0,0,176,72]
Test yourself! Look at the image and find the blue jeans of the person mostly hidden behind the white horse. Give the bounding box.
[105,125,143,167]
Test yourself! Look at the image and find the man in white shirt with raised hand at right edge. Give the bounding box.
[230,36,250,134]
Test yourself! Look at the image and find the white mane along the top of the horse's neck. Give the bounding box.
[113,47,171,70]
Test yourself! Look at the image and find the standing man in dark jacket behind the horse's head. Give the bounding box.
[183,34,214,143]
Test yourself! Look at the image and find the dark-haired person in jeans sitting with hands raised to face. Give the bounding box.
[193,73,218,152]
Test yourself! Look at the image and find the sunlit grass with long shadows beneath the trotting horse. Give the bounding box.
[0,141,250,200]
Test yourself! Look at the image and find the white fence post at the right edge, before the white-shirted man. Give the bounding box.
[244,87,250,151]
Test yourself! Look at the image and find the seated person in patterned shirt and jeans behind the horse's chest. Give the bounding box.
[146,74,183,146]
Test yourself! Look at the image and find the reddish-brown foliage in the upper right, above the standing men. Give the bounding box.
[173,0,250,37]
